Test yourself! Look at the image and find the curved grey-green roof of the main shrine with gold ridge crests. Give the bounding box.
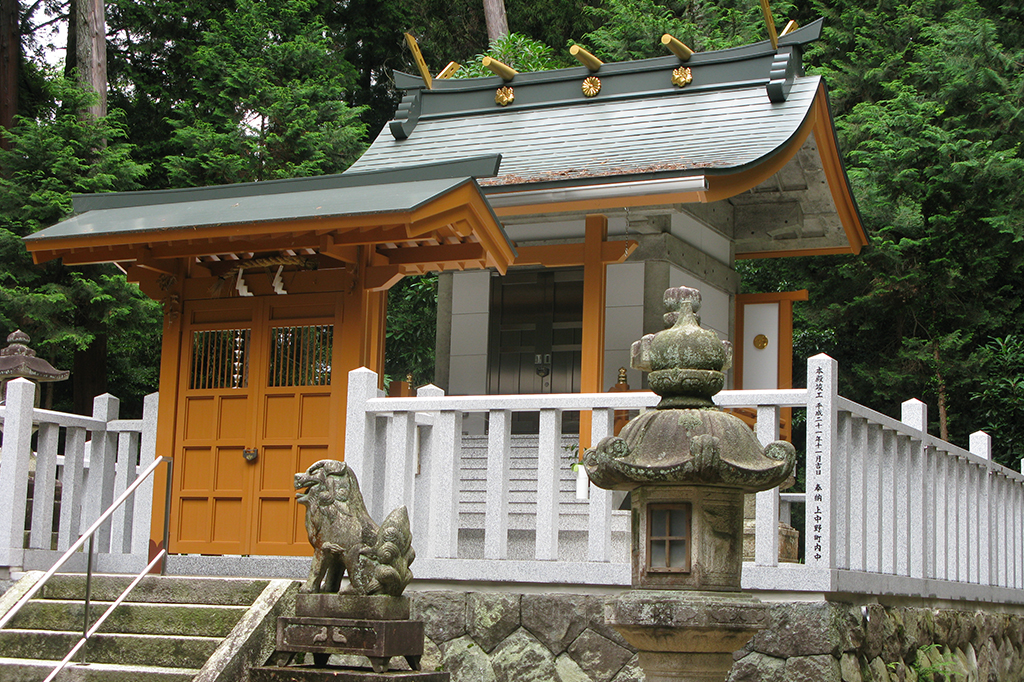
[352,19,821,187]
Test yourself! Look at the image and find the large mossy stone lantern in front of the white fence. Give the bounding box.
[584,287,796,682]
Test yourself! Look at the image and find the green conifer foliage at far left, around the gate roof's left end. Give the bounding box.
[0,76,161,413]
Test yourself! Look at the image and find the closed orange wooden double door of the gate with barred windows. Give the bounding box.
[170,294,343,555]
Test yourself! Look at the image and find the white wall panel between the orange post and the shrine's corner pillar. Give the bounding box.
[603,263,644,390]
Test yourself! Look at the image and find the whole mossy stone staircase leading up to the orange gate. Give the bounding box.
[0,572,295,682]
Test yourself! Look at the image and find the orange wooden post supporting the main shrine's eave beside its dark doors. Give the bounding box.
[580,215,608,456]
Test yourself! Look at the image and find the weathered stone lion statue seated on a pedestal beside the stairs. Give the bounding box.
[295,460,416,596]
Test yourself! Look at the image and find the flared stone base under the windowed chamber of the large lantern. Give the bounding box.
[604,590,768,682]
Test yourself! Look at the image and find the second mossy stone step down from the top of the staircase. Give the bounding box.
[7,599,248,637]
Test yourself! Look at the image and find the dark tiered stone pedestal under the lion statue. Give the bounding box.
[252,594,451,682]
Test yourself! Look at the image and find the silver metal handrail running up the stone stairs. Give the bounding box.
[0,457,173,671]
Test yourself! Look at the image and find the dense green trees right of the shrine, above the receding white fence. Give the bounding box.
[743,0,1024,466]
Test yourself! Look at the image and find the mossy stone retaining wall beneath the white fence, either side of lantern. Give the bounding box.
[407,591,1024,682]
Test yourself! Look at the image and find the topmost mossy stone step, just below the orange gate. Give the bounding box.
[41,574,268,606]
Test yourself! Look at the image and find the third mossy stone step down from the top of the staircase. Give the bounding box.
[0,629,221,668]
